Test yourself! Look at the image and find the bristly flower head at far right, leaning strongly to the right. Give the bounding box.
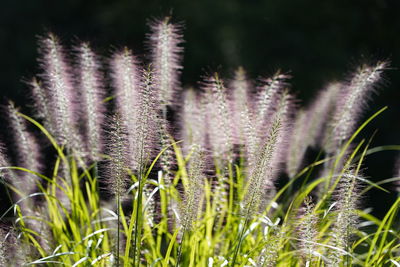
[326,62,388,152]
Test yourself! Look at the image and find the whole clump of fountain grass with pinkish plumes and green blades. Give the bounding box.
[0,18,400,267]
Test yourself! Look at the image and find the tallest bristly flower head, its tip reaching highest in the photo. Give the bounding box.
[148,17,183,105]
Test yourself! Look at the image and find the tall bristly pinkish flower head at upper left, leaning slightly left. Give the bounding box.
[37,34,80,150]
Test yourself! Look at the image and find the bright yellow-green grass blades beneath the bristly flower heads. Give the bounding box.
[1,109,400,266]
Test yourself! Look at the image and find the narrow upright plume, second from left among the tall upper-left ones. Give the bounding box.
[77,43,104,160]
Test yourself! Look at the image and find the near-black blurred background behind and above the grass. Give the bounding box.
[0,0,400,217]
